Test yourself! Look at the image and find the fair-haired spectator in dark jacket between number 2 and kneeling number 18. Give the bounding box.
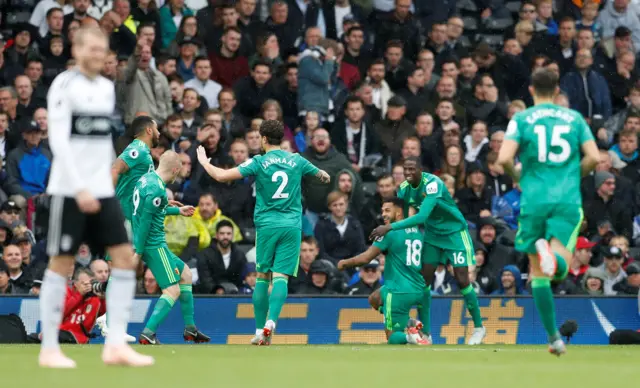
[314,191,366,264]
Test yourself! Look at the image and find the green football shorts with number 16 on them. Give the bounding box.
[422,229,476,268]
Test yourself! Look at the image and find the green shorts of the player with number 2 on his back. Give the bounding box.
[256,227,302,276]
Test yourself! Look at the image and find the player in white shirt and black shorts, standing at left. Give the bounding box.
[39,27,154,368]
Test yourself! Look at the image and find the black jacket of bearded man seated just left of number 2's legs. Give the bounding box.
[196,240,247,294]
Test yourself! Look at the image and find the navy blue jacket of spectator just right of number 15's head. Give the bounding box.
[560,70,612,120]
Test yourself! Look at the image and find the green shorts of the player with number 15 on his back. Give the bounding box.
[516,204,583,254]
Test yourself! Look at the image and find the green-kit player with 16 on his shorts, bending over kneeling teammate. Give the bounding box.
[371,157,486,345]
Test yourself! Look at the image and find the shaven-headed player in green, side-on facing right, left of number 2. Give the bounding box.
[134,151,211,345]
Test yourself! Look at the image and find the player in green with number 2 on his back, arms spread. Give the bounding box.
[198,120,330,345]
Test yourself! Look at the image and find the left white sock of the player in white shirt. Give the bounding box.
[40,269,67,349]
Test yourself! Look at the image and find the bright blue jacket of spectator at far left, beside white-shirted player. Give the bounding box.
[6,143,52,195]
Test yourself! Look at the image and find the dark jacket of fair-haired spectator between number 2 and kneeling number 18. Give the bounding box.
[314,215,366,264]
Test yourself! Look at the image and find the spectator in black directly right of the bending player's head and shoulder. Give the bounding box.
[456,163,496,224]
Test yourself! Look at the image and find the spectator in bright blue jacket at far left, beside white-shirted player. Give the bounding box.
[6,122,53,195]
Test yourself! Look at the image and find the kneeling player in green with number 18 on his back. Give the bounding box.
[338,198,430,345]
